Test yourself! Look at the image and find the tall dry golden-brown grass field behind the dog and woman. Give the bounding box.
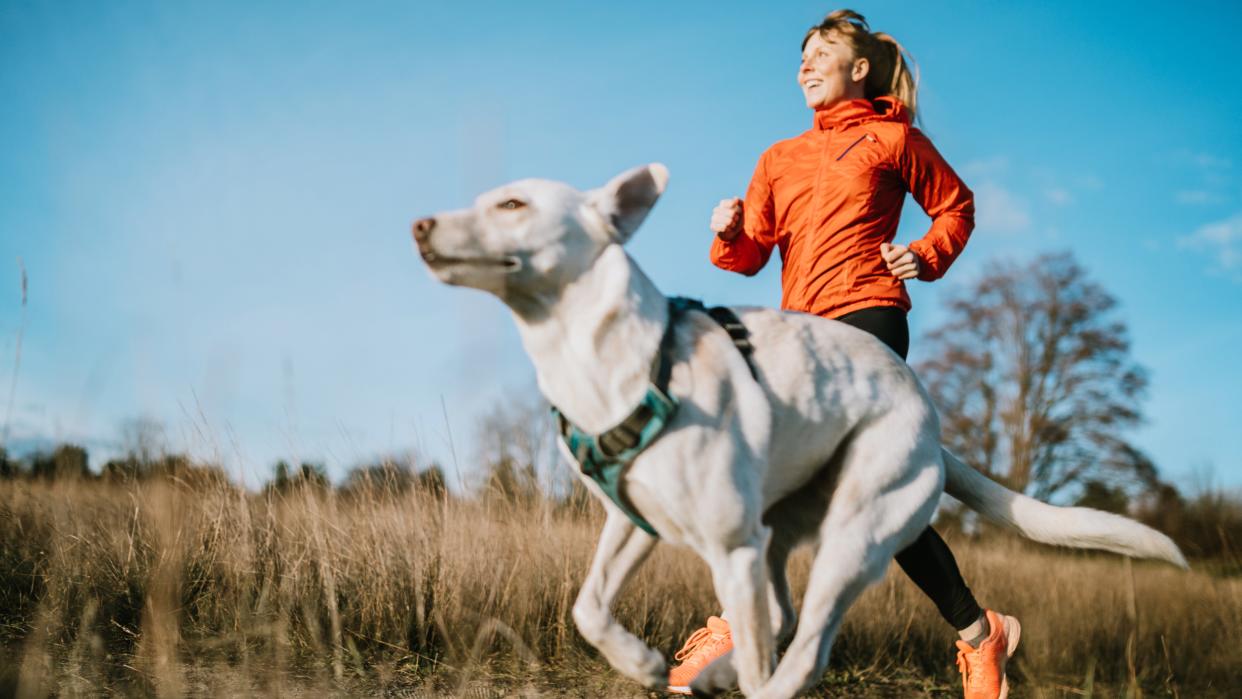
[0,478,1242,698]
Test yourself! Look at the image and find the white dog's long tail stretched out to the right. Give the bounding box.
[940,448,1189,569]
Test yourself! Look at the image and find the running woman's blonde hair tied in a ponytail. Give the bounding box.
[802,10,919,120]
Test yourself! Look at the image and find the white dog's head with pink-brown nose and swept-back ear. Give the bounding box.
[414,163,668,305]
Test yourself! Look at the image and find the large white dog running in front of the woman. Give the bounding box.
[414,164,1186,697]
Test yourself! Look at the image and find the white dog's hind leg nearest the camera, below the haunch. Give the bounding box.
[756,449,940,699]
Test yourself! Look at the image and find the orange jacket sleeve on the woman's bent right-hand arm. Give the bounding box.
[898,128,975,282]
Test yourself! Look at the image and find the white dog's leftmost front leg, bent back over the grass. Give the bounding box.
[574,508,668,689]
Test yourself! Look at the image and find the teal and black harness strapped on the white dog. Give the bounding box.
[551,297,758,536]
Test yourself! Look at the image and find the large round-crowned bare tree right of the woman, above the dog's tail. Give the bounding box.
[915,253,1156,499]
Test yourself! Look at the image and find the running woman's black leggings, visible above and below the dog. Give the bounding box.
[837,307,984,631]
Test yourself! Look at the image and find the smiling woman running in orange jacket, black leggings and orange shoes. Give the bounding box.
[669,10,1020,699]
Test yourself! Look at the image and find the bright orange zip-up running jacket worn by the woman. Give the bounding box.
[712,97,975,318]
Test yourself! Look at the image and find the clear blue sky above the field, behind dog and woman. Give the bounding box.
[0,1,1242,487]
